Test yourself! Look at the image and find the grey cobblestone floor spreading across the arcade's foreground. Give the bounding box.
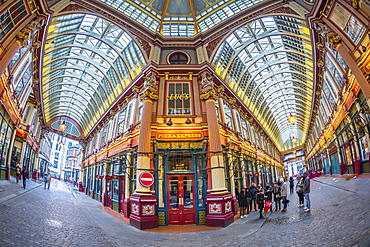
[0,178,370,247]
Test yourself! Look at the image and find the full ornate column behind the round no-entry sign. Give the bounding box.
[130,72,159,230]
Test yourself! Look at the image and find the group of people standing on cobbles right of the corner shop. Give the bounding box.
[236,173,311,219]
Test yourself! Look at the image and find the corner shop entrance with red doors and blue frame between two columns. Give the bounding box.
[155,141,207,225]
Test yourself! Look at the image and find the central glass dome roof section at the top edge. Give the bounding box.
[100,0,264,37]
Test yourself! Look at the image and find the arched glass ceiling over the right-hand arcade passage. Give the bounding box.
[213,16,313,149]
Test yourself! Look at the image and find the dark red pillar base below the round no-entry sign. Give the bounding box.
[130,195,159,230]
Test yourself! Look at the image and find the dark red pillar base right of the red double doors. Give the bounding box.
[206,192,234,227]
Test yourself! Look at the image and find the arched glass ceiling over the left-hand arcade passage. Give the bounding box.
[42,14,145,134]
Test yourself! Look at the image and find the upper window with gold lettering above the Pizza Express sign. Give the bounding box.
[167,83,190,115]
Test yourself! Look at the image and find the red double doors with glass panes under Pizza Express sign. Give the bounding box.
[167,175,195,225]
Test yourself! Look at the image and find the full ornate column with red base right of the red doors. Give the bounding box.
[200,71,234,227]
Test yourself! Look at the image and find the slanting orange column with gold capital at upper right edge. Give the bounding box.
[329,35,370,106]
